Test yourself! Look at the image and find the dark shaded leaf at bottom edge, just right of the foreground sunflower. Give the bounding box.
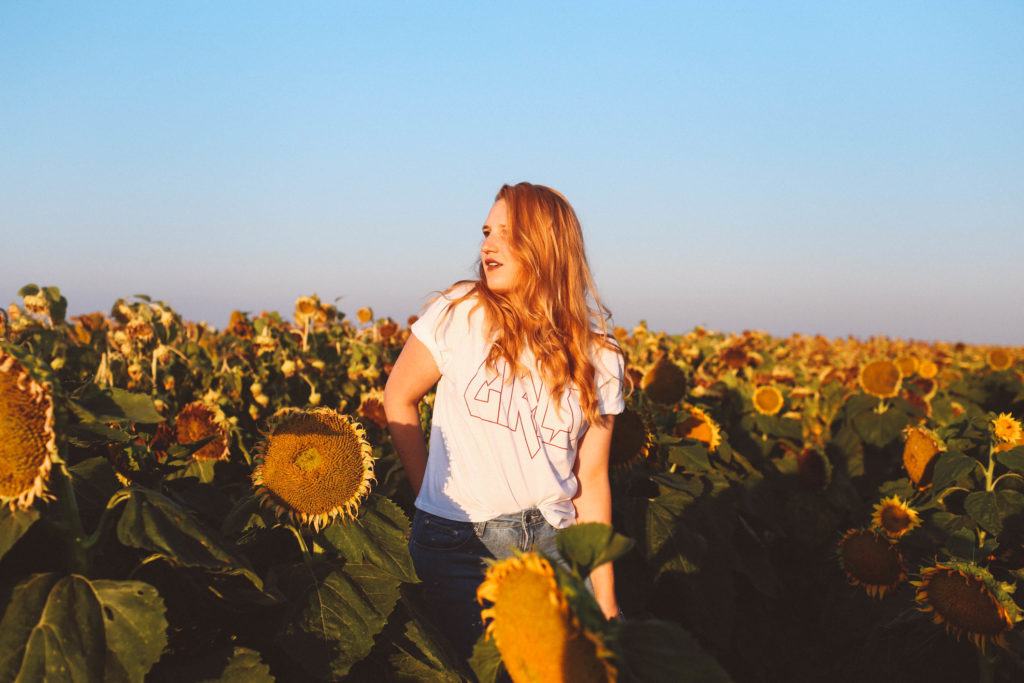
[615,620,732,683]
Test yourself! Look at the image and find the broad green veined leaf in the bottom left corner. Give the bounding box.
[0,573,167,682]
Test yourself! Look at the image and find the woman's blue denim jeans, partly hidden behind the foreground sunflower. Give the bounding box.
[409,507,594,675]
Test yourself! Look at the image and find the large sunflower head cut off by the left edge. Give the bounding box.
[0,356,57,512]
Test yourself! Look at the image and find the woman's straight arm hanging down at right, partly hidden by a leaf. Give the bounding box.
[572,415,618,618]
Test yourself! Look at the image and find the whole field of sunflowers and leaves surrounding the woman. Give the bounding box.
[0,285,1024,683]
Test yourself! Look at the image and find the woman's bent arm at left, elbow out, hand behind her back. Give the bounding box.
[384,334,441,496]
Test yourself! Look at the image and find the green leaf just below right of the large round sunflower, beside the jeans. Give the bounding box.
[322,494,420,584]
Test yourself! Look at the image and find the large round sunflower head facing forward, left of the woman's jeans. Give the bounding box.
[252,408,376,529]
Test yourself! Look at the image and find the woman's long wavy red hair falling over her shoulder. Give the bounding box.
[419,182,633,426]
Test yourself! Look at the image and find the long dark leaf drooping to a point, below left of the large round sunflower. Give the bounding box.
[118,487,263,589]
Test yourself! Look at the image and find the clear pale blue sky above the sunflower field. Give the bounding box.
[0,0,1024,344]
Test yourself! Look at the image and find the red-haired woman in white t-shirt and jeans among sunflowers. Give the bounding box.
[384,182,625,671]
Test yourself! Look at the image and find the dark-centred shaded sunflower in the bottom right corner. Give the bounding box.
[910,561,1022,652]
